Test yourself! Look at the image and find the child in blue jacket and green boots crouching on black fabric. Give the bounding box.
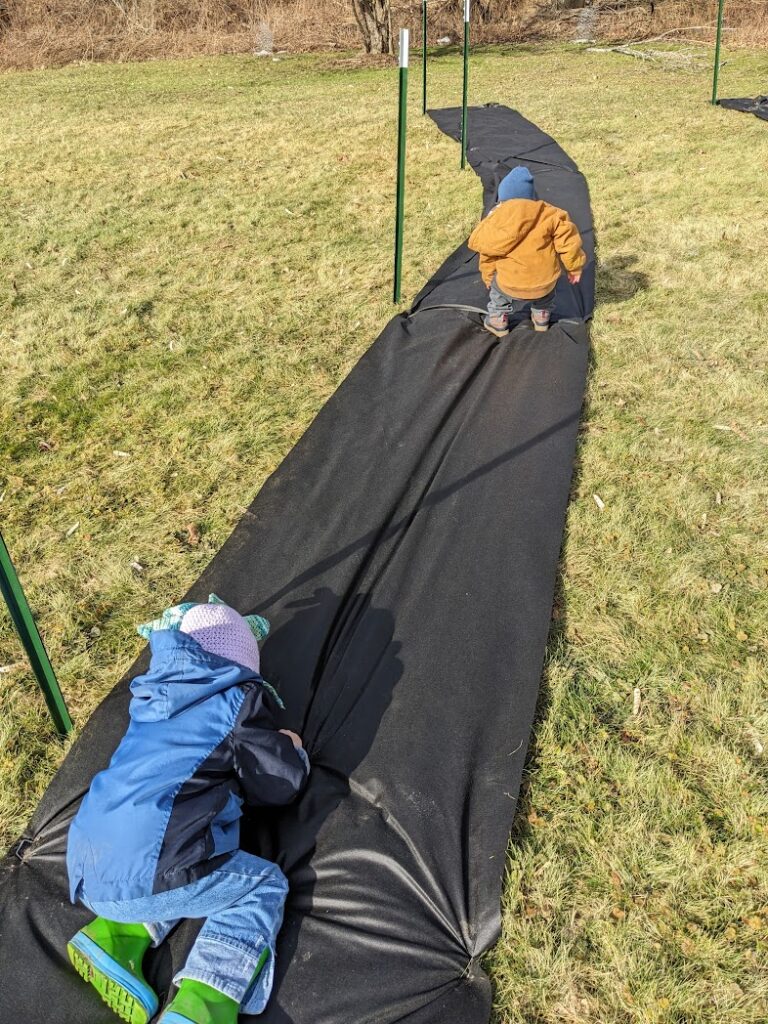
[64,595,309,1024]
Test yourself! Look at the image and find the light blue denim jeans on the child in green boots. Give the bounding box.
[80,850,288,1014]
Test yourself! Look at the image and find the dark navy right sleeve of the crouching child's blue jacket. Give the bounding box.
[232,690,309,807]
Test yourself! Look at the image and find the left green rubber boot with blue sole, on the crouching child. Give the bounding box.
[67,918,158,1024]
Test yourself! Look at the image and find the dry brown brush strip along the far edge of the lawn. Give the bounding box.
[0,0,768,70]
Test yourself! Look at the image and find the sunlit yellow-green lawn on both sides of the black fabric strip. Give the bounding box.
[0,41,768,1024]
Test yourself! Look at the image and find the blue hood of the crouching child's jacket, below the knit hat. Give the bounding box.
[129,630,260,722]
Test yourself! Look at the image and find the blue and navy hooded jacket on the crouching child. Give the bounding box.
[67,630,309,902]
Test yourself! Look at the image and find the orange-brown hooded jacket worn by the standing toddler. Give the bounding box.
[469,199,587,299]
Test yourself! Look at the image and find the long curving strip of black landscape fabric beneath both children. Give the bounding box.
[0,106,594,1024]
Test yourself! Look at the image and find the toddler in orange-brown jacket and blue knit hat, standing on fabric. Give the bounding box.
[469,167,587,338]
